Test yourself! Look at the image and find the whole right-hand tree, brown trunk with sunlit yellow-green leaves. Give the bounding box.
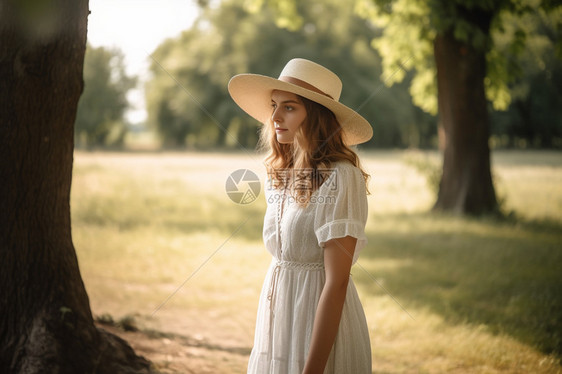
[352,0,548,214]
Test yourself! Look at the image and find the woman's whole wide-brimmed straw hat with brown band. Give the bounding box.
[228,58,373,145]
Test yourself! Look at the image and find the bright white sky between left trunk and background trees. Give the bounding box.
[88,0,198,123]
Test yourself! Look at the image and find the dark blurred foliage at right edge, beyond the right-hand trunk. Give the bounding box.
[488,7,562,148]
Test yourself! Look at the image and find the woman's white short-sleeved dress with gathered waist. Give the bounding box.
[248,162,371,374]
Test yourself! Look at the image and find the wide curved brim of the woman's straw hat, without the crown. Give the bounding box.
[228,74,373,145]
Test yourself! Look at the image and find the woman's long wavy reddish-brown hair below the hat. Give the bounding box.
[259,95,369,206]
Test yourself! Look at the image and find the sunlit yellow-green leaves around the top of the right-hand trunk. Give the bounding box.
[356,0,562,114]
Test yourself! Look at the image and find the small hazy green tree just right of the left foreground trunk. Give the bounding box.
[75,45,136,148]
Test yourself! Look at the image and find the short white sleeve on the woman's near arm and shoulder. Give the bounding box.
[311,162,368,262]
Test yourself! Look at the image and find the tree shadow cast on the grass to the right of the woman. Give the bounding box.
[354,213,562,358]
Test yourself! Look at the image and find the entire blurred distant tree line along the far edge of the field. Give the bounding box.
[76,0,562,148]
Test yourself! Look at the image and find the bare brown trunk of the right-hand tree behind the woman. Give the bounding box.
[434,33,497,214]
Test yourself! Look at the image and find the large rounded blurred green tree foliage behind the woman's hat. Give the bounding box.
[146,0,436,148]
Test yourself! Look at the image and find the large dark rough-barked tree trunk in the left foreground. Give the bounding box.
[0,0,149,374]
